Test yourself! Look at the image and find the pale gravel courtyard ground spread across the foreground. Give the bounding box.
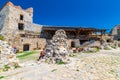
[0,49,120,80]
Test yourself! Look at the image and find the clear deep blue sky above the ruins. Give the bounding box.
[0,0,120,32]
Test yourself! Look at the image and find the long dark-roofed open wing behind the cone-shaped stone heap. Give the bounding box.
[41,26,107,47]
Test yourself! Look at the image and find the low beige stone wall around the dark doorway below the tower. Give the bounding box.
[14,38,46,51]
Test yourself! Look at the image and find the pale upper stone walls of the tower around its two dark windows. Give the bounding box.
[0,2,42,42]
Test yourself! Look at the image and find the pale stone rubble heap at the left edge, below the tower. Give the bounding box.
[0,40,18,70]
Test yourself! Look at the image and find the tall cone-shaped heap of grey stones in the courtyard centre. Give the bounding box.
[45,30,69,63]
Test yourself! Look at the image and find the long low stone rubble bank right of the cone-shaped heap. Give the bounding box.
[75,41,120,52]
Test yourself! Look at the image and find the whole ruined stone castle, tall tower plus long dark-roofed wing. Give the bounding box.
[0,2,110,51]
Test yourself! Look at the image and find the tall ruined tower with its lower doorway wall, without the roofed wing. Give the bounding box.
[0,2,46,51]
